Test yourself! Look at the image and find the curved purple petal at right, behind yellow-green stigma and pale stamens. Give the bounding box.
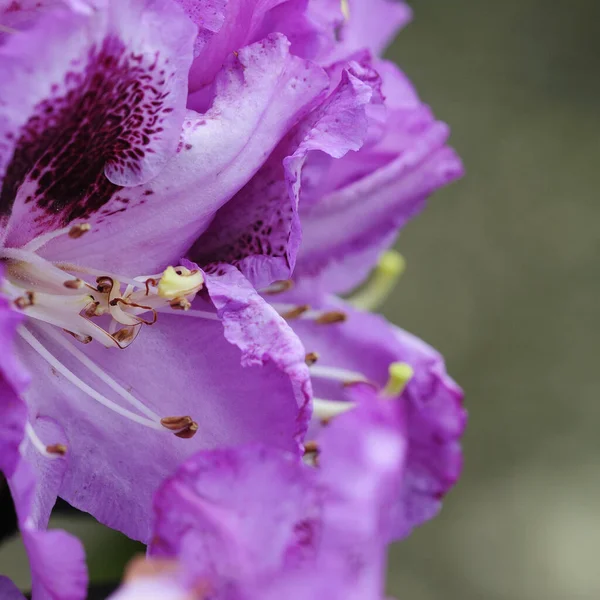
[285,292,466,539]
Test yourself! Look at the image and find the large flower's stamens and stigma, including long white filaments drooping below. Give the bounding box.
[0,224,206,448]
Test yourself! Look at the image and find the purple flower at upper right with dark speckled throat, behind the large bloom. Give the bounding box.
[191,0,463,293]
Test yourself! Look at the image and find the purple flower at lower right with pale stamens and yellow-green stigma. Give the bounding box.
[274,282,466,539]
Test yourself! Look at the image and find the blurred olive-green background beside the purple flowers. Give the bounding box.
[0,0,600,600]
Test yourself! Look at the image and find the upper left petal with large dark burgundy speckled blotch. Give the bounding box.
[0,0,194,245]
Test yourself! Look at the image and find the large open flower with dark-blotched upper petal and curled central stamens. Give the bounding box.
[0,0,372,540]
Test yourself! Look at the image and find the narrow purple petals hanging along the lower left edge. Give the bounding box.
[0,288,87,600]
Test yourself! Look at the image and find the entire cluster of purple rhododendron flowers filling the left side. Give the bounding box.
[0,0,465,600]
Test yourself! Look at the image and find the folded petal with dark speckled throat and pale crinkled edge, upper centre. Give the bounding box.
[191,63,373,287]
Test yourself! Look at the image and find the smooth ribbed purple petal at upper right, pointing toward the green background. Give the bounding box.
[295,63,463,293]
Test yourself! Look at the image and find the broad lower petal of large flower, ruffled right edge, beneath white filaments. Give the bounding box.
[21,272,310,542]
